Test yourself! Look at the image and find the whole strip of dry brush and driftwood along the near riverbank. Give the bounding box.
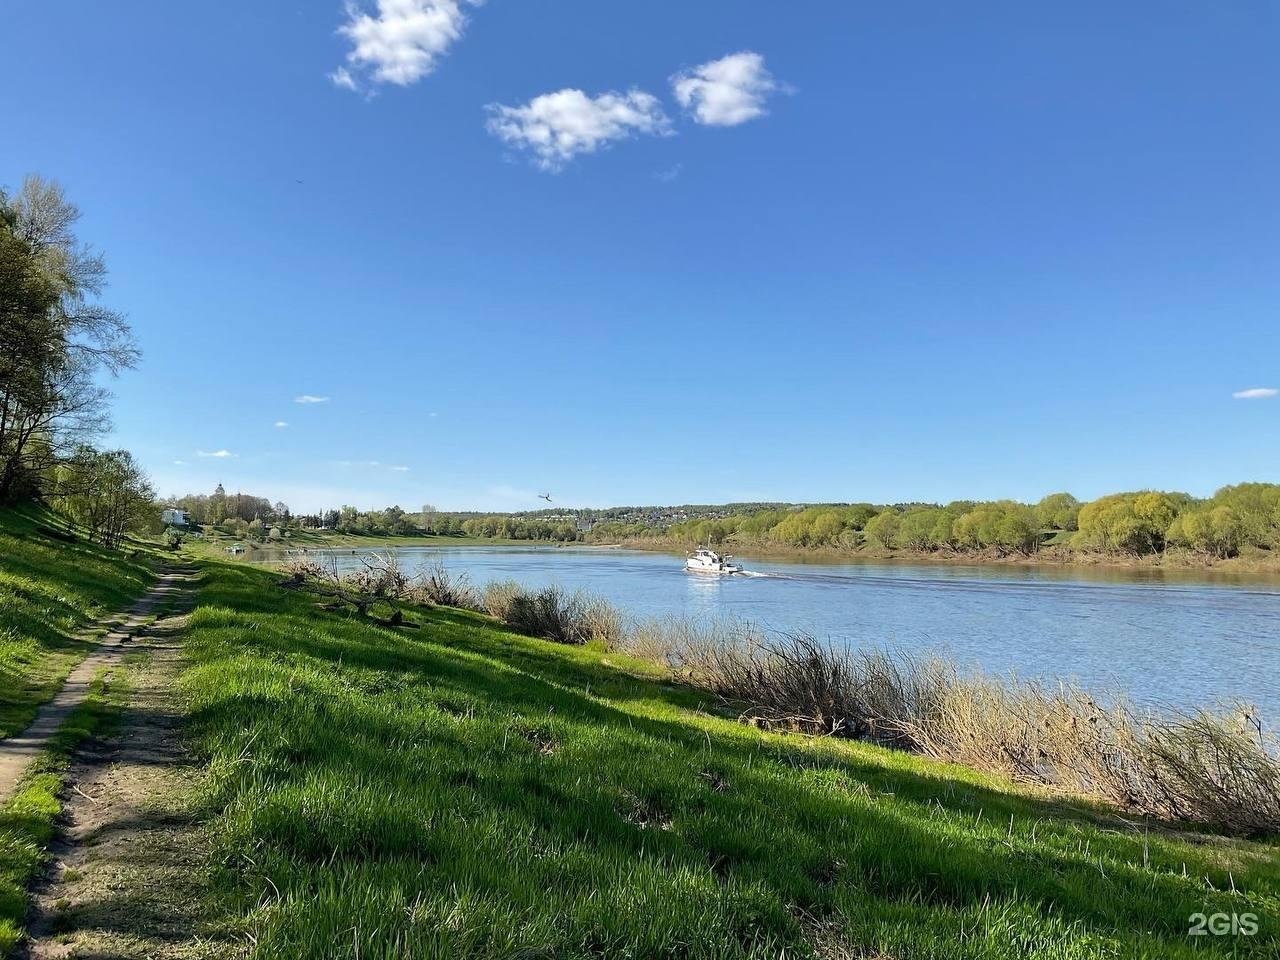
[285,554,1280,836]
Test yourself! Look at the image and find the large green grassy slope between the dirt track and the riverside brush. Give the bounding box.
[184,563,1280,959]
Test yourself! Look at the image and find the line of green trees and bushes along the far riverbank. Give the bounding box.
[183,483,1280,570]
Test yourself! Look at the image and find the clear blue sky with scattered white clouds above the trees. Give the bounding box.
[0,0,1280,509]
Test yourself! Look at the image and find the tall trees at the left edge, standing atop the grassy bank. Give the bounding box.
[0,177,155,545]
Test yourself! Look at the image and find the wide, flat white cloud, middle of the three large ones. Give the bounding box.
[486,88,671,172]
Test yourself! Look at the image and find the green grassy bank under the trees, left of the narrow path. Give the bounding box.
[0,508,157,739]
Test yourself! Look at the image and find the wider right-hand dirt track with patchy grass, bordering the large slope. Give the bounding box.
[26,618,241,960]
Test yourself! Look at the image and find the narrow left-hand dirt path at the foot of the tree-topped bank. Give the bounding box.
[0,571,189,801]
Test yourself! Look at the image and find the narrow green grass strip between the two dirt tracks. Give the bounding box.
[0,672,125,957]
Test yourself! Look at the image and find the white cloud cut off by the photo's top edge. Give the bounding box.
[329,0,483,90]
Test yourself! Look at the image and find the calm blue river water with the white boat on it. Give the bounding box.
[267,547,1280,726]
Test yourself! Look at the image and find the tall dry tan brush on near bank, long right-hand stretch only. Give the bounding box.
[641,630,1280,836]
